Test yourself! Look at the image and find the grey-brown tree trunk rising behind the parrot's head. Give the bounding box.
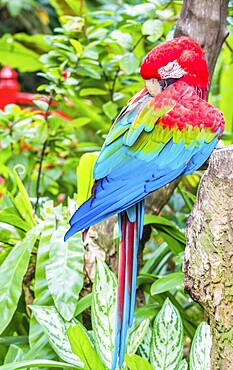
[175,0,229,80]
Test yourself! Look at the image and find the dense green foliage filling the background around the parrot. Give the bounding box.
[0,0,233,370]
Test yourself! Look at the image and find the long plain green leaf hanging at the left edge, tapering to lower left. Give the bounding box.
[0,223,43,333]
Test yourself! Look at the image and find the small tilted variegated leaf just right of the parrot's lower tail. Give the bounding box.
[127,319,150,355]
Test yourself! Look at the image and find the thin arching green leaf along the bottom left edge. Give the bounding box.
[0,360,77,370]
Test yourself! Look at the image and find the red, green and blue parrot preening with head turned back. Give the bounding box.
[65,36,224,370]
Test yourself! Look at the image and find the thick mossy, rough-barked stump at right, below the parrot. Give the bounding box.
[184,146,233,370]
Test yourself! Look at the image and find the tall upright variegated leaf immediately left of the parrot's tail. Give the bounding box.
[91,259,117,368]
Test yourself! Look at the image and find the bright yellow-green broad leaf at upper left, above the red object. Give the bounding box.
[0,35,43,72]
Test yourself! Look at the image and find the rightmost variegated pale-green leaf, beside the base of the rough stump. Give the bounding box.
[190,322,212,370]
